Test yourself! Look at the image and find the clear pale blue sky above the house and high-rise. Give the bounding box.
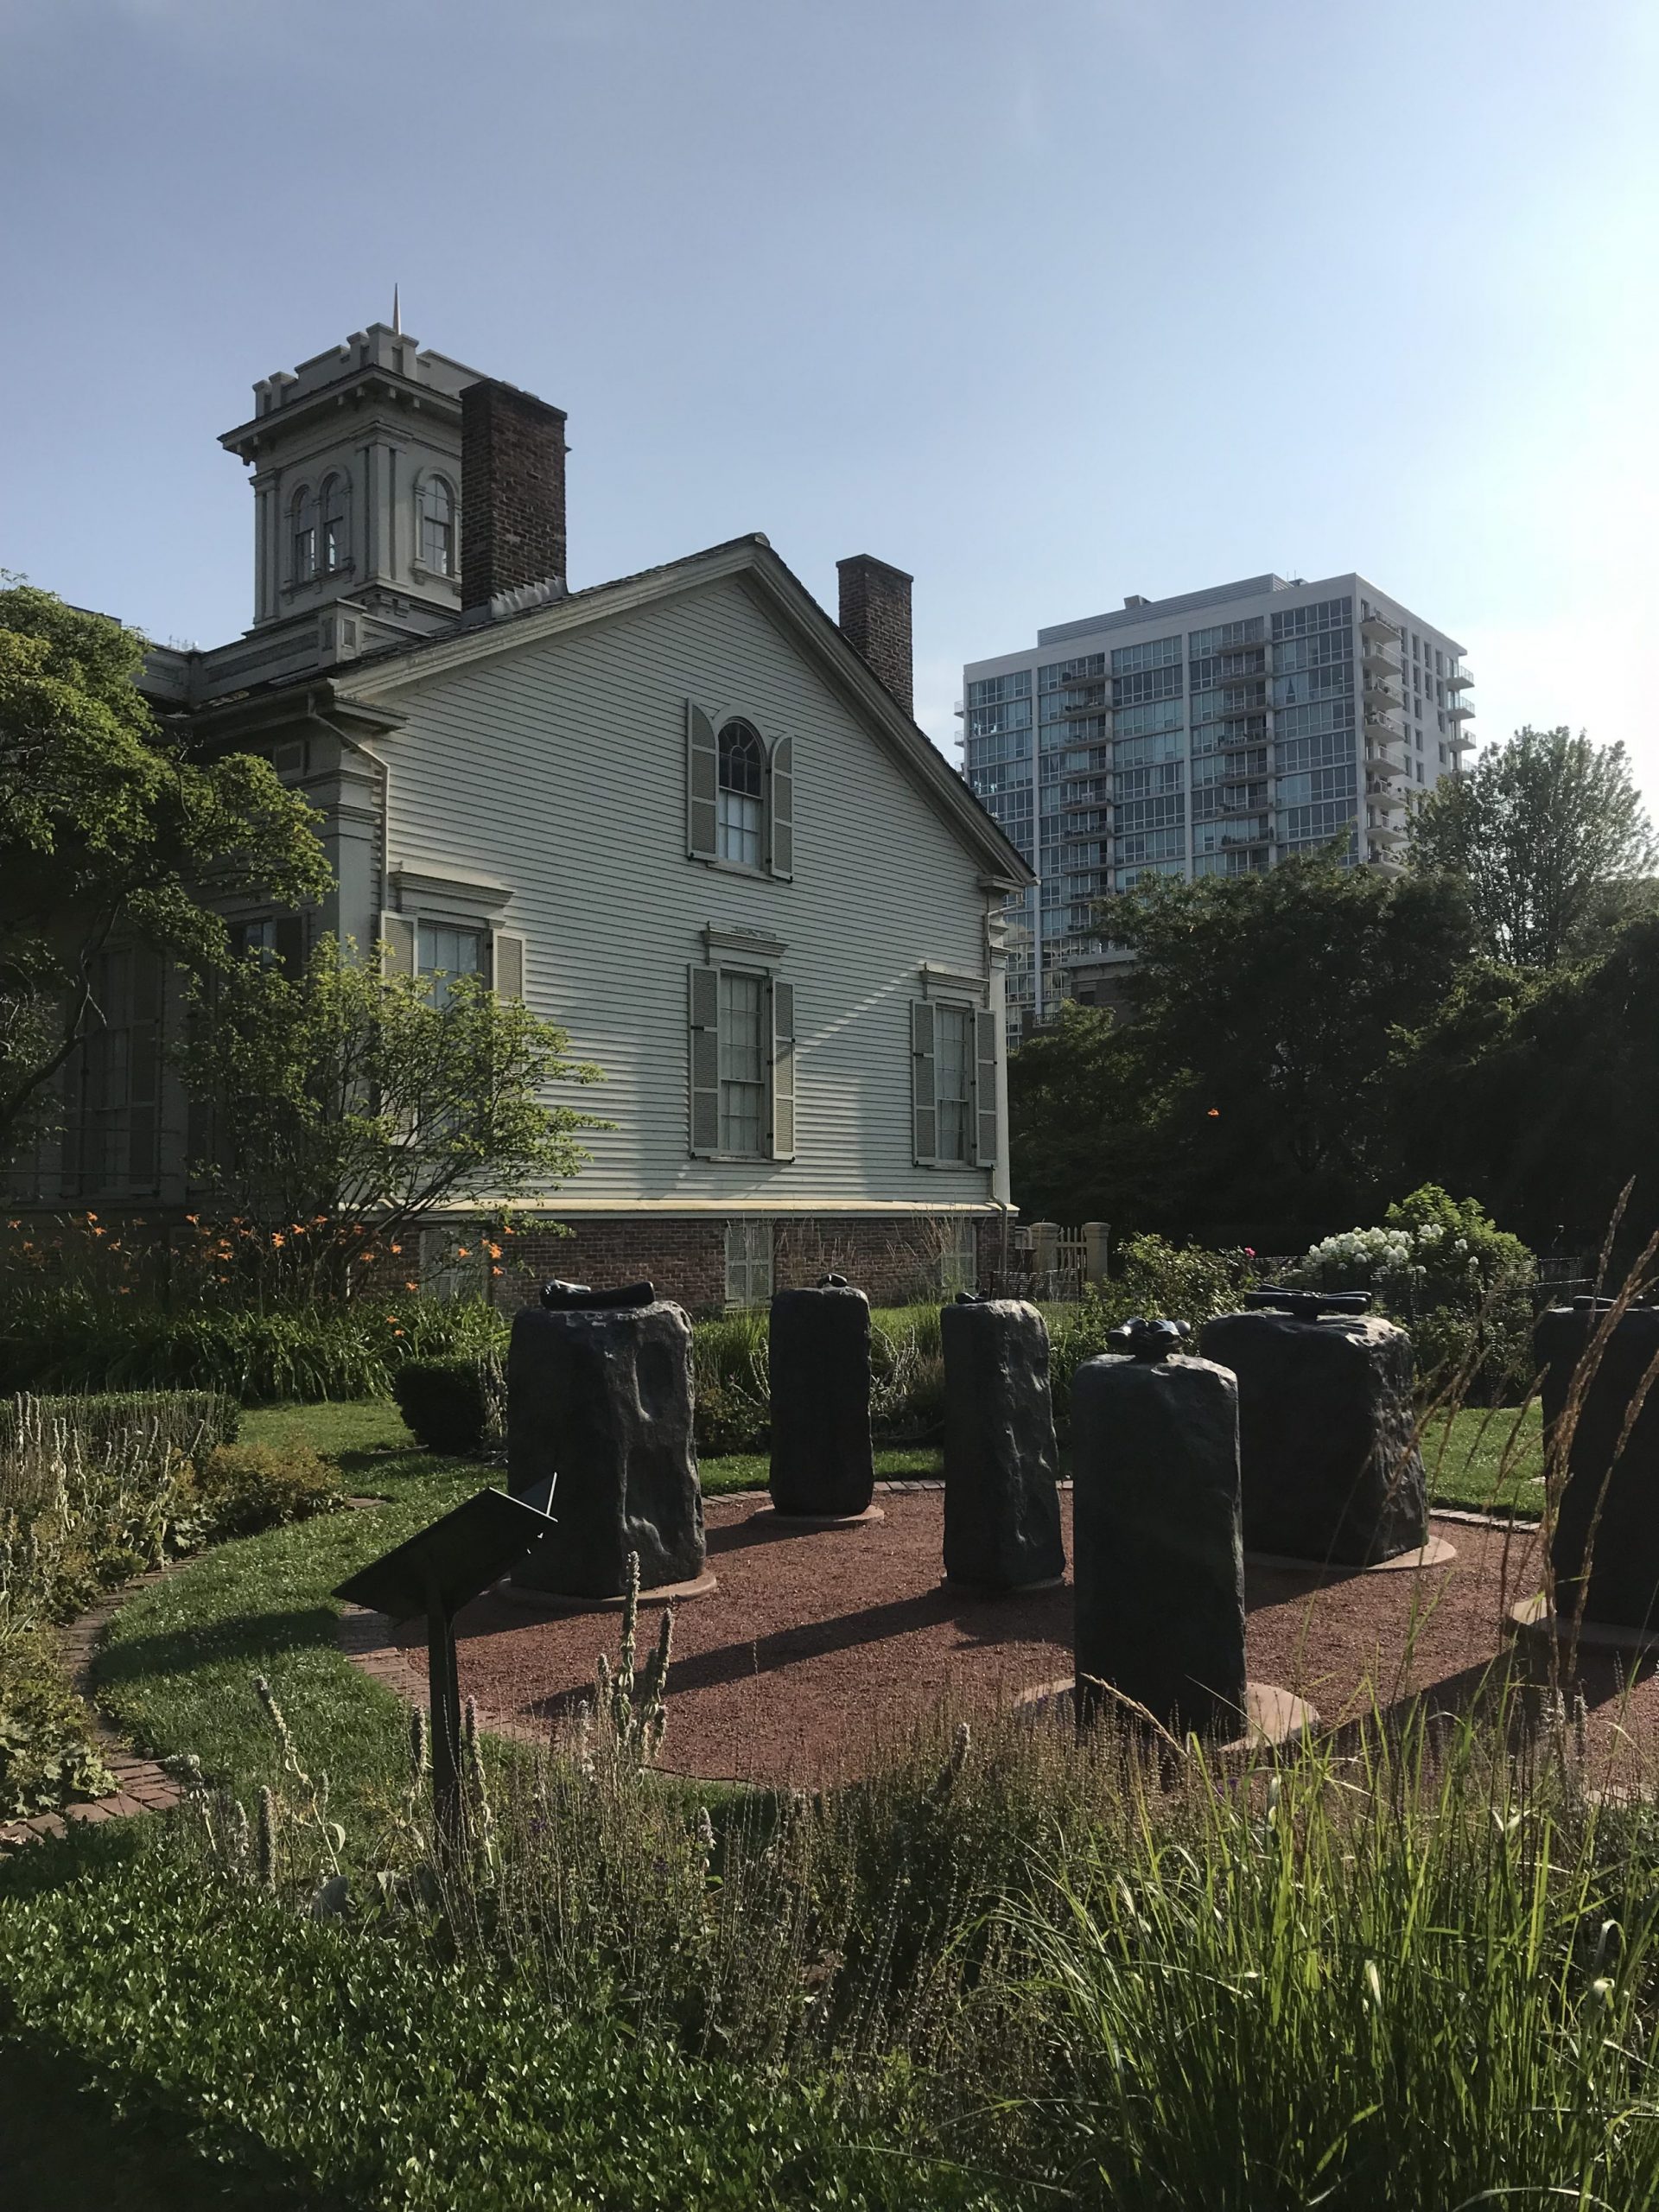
[0,0,1659,801]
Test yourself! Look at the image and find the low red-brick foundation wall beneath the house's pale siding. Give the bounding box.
[495,1214,1002,1314]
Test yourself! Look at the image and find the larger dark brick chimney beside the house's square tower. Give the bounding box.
[460,376,564,613]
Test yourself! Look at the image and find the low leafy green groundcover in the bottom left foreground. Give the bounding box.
[0,1834,986,2212]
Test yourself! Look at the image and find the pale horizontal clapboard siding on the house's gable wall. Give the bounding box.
[373,582,991,1210]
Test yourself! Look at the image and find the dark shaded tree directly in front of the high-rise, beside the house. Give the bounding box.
[1008,852,1471,1249]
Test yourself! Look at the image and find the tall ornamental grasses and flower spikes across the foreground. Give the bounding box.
[181,1583,1659,2212]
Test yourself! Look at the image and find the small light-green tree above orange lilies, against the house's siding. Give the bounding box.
[175,938,608,1292]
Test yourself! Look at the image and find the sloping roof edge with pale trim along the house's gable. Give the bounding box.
[316,533,1035,889]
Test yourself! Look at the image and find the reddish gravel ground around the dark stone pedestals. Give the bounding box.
[380,1491,1659,1785]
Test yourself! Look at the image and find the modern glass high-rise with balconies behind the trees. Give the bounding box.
[960,575,1473,1042]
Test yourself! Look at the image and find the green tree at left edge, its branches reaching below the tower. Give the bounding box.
[0,582,327,1159]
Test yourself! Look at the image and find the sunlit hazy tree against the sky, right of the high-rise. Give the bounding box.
[1409,728,1659,969]
